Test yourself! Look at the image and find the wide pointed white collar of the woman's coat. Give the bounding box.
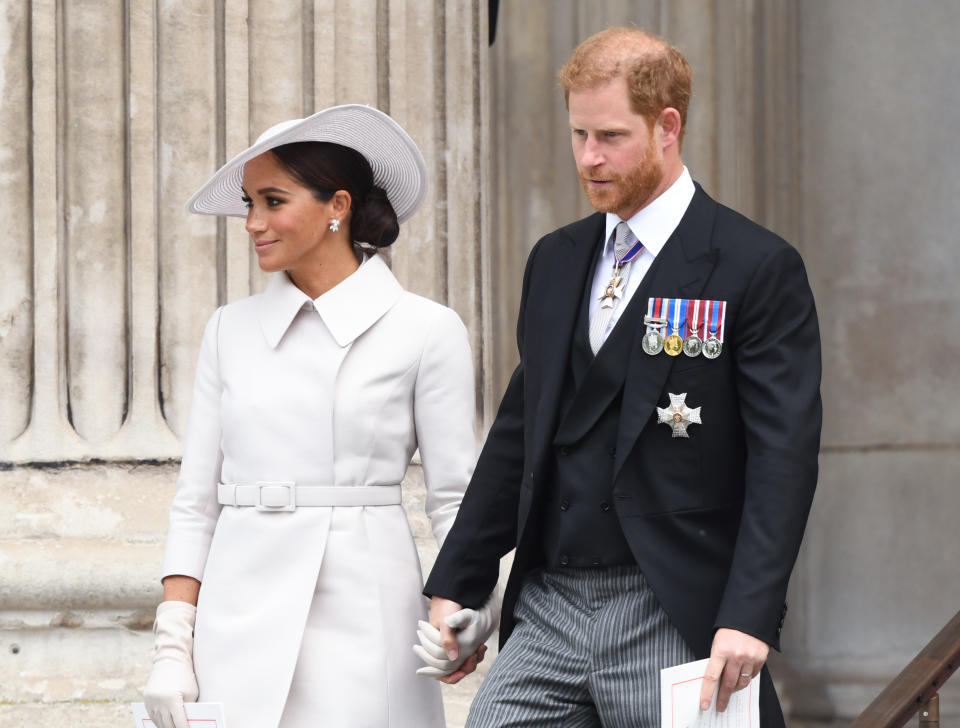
[258,254,403,348]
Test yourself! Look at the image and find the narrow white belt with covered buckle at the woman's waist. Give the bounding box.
[217,480,401,511]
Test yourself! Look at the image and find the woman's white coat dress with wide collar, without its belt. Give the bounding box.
[163,255,475,728]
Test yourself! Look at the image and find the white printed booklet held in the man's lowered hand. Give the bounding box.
[660,660,760,728]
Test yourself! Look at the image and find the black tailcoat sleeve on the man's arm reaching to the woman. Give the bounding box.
[424,243,540,608]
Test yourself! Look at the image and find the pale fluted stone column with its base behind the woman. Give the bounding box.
[0,0,490,726]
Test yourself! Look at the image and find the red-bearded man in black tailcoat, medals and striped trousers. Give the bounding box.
[425,28,821,728]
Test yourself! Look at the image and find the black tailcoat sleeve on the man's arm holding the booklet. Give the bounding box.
[715,245,822,649]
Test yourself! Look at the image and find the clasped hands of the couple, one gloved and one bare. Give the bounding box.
[413,589,500,684]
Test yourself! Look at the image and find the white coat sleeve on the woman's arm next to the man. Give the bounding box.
[413,308,477,546]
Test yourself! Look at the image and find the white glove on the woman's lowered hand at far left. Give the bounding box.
[143,602,200,728]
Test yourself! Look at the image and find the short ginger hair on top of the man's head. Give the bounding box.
[558,28,693,141]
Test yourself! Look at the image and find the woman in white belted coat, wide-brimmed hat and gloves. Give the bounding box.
[145,105,496,728]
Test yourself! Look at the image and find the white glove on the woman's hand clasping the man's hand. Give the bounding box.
[413,588,500,677]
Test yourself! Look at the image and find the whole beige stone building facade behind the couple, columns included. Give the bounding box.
[7,0,960,726]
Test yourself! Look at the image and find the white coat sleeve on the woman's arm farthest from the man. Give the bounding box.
[162,309,229,581]
